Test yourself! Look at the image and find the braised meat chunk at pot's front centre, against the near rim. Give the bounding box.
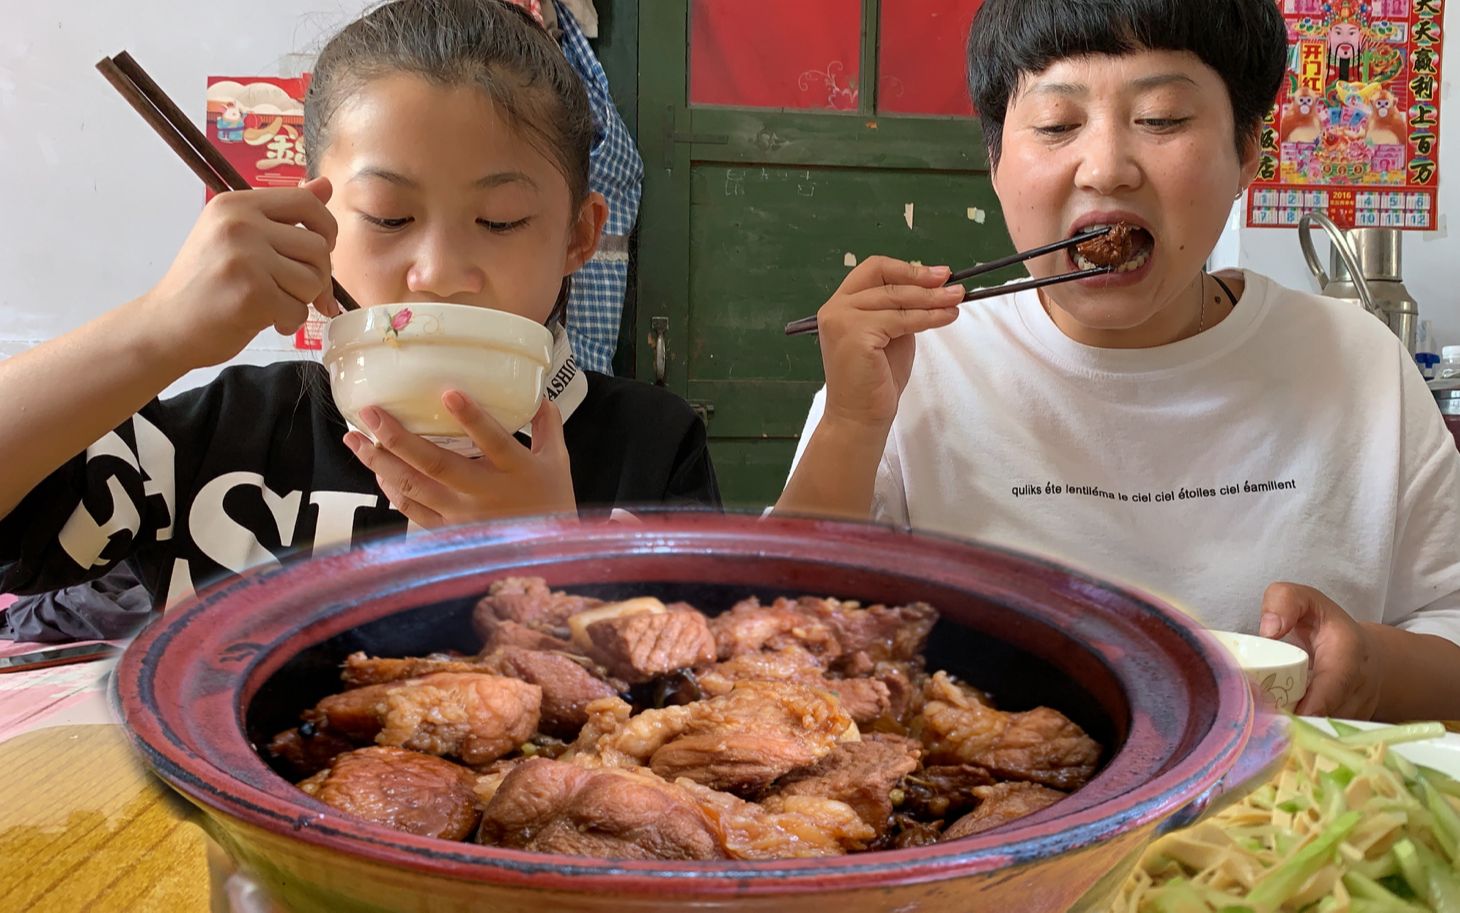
[477,758,726,859]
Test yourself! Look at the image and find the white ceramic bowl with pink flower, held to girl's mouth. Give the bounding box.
[324,302,552,453]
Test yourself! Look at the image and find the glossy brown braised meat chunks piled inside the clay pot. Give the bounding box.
[270,572,1097,860]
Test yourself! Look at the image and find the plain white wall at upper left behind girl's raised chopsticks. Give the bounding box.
[0,0,368,389]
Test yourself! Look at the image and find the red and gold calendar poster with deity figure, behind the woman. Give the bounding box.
[1247,0,1444,231]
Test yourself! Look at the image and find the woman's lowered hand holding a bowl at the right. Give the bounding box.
[1259,583,1383,720]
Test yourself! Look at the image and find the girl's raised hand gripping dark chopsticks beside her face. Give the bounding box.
[133,178,339,370]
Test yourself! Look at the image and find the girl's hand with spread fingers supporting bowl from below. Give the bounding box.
[345,390,578,529]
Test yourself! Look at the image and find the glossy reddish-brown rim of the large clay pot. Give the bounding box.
[112,511,1253,895]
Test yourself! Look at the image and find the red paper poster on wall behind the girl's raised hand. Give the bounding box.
[207,73,324,349]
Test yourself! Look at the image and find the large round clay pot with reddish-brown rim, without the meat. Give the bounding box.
[115,513,1282,913]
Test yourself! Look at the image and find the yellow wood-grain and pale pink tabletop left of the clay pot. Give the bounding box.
[0,651,213,913]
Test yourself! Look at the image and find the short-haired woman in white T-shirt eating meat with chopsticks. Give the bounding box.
[777,0,1460,719]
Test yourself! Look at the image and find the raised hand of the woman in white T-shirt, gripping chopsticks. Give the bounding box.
[816,257,964,429]
